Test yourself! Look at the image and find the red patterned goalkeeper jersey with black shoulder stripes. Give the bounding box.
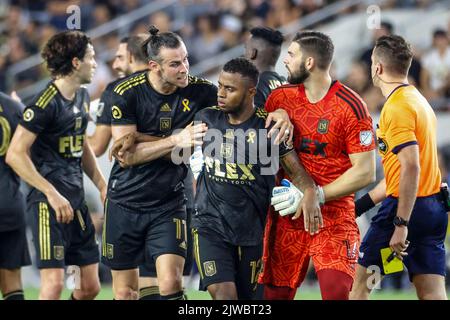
[265,81,375,224]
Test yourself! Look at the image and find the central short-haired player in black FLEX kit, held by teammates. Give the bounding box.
[192,58,320,300]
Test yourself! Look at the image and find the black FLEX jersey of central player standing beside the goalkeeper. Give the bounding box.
[192,108,293,246]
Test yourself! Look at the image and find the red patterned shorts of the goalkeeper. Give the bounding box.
[258,207,360,288]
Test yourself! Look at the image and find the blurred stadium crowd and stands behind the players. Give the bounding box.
[0,0,450,299]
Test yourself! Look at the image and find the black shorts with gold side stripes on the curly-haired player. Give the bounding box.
[28,201,99,269]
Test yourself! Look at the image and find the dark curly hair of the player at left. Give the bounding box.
[41,30,92,78]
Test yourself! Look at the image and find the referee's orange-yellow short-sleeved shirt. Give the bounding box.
[377,85,441,197]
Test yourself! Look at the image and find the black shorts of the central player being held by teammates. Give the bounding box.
[193,229,263,300]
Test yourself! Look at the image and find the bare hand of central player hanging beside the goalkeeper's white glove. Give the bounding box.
[292,188,324,235]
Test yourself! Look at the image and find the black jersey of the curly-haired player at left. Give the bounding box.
[20,82,89,208]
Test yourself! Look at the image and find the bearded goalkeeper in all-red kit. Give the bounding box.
[260,31,375,299]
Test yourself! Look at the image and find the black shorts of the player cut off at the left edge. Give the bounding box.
[0,225,31,269]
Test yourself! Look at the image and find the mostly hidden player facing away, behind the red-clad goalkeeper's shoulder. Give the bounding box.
[245,27,286,108]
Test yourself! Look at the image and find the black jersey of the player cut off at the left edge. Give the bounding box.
[0,92,25,232]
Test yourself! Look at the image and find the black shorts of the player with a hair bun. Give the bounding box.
[102,201,187,270]
